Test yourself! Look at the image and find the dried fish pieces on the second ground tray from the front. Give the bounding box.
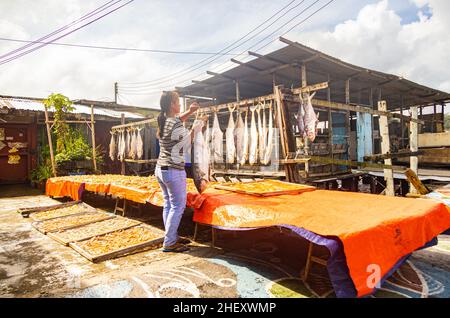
[49,217,141,244]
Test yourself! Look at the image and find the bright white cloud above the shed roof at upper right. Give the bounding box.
[290,0,450,92]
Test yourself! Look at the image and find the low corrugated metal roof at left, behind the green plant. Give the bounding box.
[0,97,145,119]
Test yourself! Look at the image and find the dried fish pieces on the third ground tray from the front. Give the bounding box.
[33,212,115,234]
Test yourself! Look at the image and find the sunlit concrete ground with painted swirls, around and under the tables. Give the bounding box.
[0,186,450,298]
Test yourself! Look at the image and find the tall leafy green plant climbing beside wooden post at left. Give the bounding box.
[44,94,75,152]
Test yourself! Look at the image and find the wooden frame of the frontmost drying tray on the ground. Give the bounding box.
[69,224,164,263]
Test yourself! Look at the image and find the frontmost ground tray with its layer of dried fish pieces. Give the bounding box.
[70,225,164,262]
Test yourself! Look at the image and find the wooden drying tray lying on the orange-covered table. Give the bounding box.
[213,180,316,197]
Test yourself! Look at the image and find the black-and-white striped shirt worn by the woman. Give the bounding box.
[156,116,190,170]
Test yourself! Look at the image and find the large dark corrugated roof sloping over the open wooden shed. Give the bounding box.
[179,38,450,109]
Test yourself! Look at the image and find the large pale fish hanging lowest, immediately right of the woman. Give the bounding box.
[191,119,210,193]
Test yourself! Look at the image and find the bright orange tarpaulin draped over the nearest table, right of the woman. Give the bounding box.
[194,188,450,296]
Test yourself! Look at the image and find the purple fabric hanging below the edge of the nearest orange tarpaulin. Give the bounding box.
[208,224,437,298]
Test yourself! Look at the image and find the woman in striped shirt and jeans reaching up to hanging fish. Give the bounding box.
[155,92,199,252]
